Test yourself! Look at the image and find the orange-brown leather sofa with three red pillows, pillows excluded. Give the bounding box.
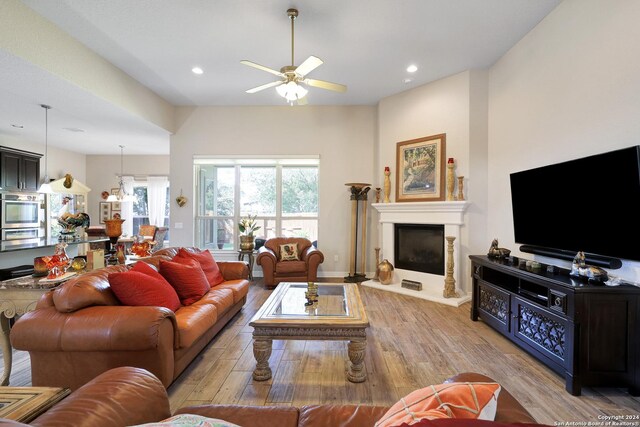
[11,248,249,390]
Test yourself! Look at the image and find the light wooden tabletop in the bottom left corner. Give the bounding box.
[0,387,71,423]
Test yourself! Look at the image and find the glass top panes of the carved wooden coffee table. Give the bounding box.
[268,283,349,317]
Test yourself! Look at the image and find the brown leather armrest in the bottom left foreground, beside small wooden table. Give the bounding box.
[31,366,171,427]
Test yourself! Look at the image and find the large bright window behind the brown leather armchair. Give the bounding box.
[194,158,319,250]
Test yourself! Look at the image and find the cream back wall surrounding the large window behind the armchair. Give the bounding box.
[170,106,376,275]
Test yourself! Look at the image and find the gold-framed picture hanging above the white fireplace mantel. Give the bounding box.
[396,133,446,202]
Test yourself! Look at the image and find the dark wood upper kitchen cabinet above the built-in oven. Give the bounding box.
[0,147,42,191]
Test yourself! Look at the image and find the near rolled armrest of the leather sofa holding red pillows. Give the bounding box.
[11,306,179,351]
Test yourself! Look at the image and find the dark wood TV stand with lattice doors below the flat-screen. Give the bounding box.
[469,255,640,396]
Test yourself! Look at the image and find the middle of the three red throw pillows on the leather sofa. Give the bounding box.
[160,258,211,305]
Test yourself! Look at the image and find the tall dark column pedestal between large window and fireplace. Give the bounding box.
[344,182,371,282]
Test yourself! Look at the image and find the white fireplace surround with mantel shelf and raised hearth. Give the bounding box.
[362,201,471,307]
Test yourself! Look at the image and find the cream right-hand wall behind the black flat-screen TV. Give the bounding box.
[487,0,640,282]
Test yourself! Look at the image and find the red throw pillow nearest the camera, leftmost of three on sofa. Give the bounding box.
[109,268,180,312]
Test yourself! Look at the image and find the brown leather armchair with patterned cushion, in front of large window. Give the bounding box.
[256,237,324,288]
